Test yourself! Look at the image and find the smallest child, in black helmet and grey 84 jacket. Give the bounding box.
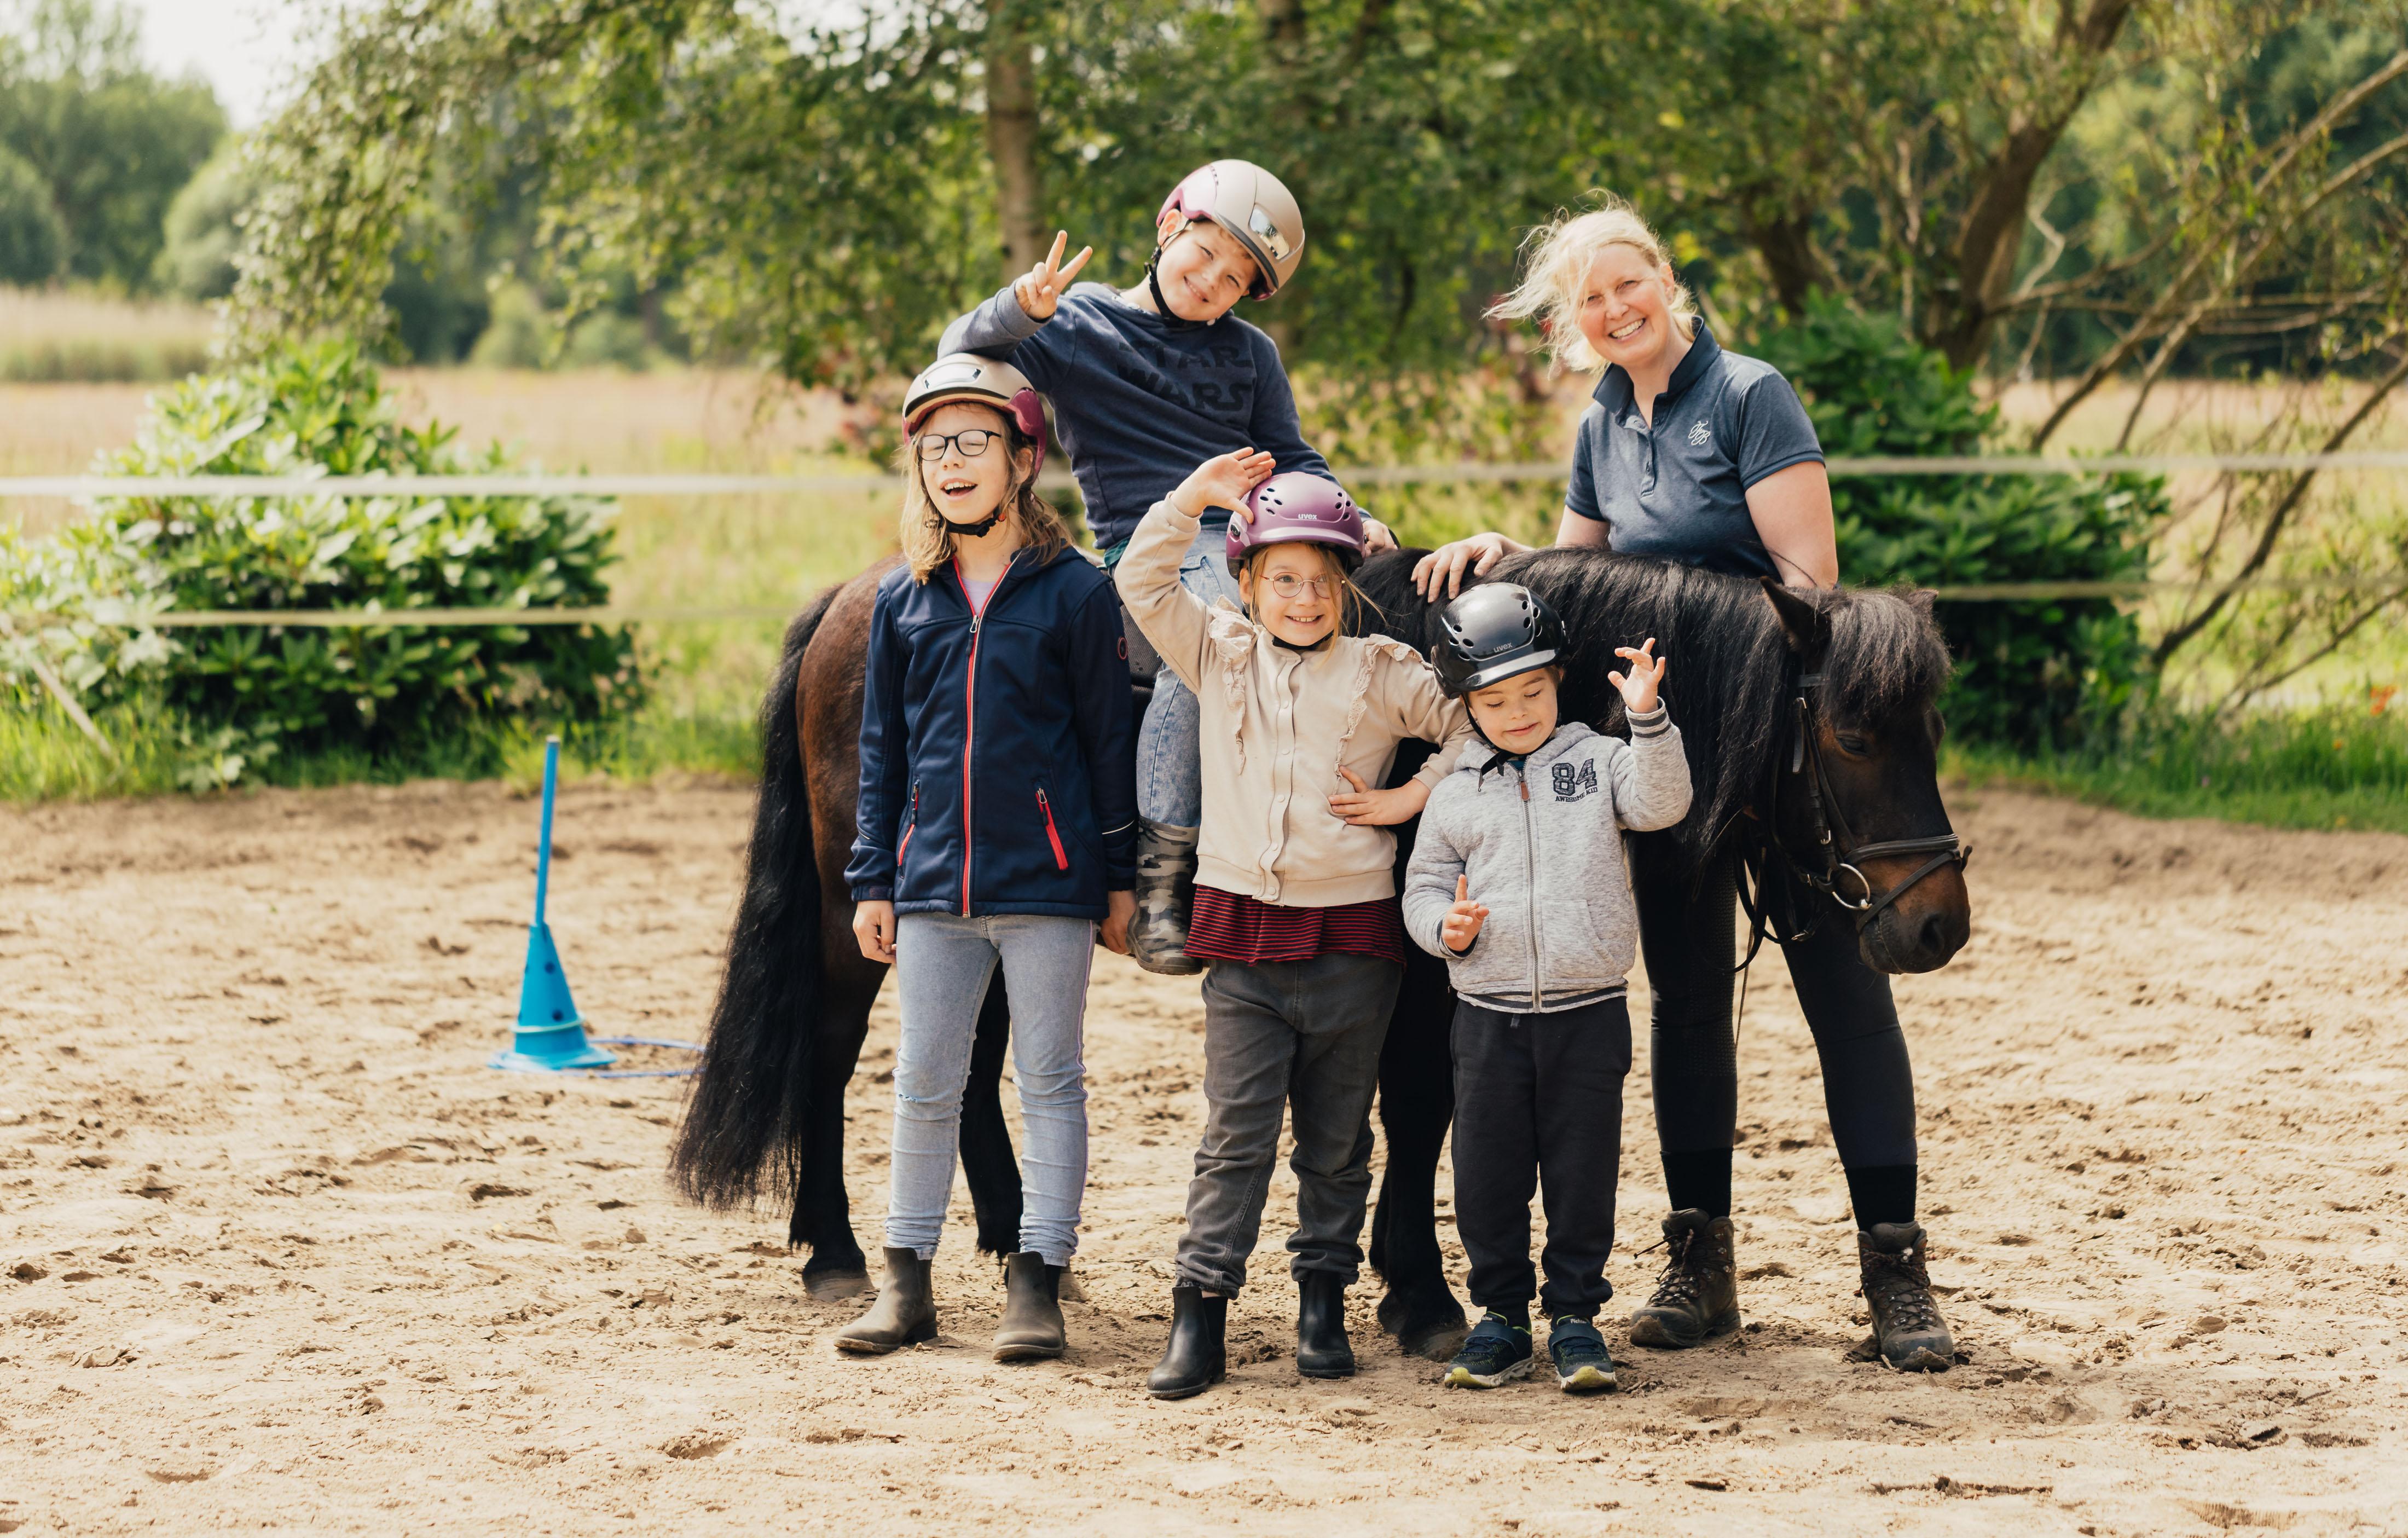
[1404,582,1691,1394]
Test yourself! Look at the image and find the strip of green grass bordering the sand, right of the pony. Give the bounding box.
[1948,705,2408,833]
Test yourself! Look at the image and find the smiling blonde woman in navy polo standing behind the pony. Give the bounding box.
[1414,198,1953,1369]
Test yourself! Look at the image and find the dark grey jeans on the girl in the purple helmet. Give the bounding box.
[1175,956,1404,1295]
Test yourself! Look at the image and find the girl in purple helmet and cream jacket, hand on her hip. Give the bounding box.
[1118,450,1471,1398]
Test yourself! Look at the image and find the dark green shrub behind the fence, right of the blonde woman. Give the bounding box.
[1756,298,2169,749]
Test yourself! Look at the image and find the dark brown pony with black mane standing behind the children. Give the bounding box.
[669,551,1970,1328]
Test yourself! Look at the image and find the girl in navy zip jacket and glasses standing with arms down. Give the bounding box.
[836,356,1137,1362]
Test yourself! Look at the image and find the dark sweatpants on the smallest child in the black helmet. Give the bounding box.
[1455,997,1630,1319]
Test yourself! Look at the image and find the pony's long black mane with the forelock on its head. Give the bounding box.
[1356,549,1950,859]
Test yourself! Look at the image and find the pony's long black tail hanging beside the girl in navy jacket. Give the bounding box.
[669,587,838,1209]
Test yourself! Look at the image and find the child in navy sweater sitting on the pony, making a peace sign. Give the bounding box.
[944,161,1394,975]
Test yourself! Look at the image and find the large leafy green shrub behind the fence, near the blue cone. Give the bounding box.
[0,342,638,782]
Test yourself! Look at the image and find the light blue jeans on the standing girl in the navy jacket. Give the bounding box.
[886,912,1096,1266]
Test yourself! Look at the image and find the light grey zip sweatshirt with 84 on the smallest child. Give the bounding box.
[1404,708,1688,1016]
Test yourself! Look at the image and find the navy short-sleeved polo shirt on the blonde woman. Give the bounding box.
[1563,322,1823,577]
